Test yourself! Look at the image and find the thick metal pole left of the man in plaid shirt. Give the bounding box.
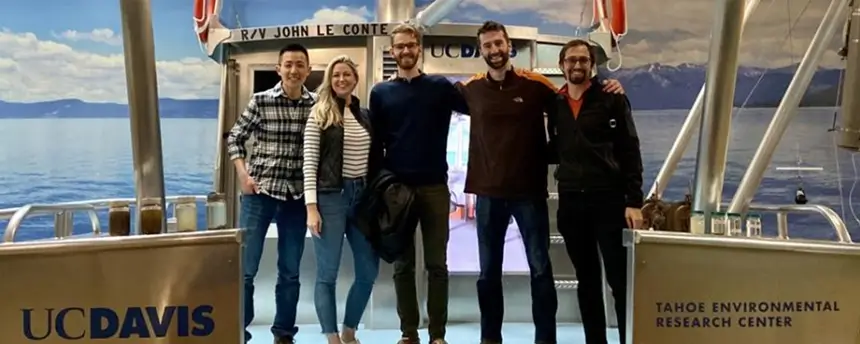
[119,0,167,232]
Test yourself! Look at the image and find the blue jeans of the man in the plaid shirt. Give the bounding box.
[239,194,307,342]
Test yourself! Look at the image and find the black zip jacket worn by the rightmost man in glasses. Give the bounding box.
[547,81,643,208]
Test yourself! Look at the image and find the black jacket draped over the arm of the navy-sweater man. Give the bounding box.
[353,170,418,263]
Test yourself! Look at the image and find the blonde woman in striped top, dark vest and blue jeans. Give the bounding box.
[303,56,379,344]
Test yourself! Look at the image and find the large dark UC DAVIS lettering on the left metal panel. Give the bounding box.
[21,305,215,341]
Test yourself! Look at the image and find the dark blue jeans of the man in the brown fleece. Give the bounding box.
[477,196,558,343]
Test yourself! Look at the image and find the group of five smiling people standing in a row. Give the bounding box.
[228,21,643,344]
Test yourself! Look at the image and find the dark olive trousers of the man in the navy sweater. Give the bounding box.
[394,184,450,341]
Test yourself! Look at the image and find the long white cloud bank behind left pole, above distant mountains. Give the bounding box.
[0,29,220,103]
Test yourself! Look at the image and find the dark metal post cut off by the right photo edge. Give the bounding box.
[839,0,860,150]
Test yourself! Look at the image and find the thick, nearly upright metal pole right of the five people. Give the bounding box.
[693,0,744,230]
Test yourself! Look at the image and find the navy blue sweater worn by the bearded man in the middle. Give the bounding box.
[370,74,468,186]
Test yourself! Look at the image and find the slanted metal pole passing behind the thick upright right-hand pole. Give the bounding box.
[648,0,761,197]
